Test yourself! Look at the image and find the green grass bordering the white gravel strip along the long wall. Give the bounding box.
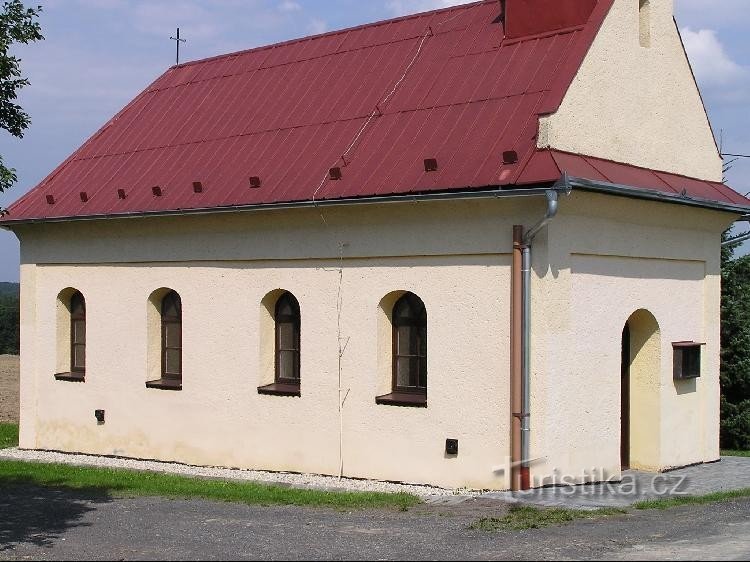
[0,424,421,511]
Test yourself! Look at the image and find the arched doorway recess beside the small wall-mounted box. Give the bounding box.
[620,310,661,470]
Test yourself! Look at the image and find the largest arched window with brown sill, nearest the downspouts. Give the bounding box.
[377,293,427,407]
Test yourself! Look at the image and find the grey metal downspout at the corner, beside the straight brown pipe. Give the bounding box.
[516,178,570,490]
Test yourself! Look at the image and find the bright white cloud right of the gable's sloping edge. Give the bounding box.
[682,27,747,87]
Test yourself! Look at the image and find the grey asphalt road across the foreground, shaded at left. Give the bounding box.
[0,485,750,560]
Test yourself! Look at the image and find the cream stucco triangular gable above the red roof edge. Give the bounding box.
[538,0,722,181]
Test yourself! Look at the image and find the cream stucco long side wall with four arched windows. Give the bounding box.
[14,201,544,489]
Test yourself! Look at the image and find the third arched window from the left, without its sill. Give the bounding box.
[275,293,301,387]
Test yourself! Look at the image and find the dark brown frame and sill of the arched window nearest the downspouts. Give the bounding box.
[376,293,428,408]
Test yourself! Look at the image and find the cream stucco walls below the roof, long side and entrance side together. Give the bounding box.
[17,193,733,489]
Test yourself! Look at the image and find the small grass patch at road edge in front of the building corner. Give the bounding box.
[470,505,627,531]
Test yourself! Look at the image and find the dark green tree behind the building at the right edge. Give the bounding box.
[721,234,750,450]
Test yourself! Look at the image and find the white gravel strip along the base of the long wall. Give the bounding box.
[0,449,476,500]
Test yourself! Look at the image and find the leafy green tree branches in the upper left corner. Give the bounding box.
[0,0,44,197]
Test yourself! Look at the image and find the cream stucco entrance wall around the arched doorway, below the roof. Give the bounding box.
[532,193,732,483]
